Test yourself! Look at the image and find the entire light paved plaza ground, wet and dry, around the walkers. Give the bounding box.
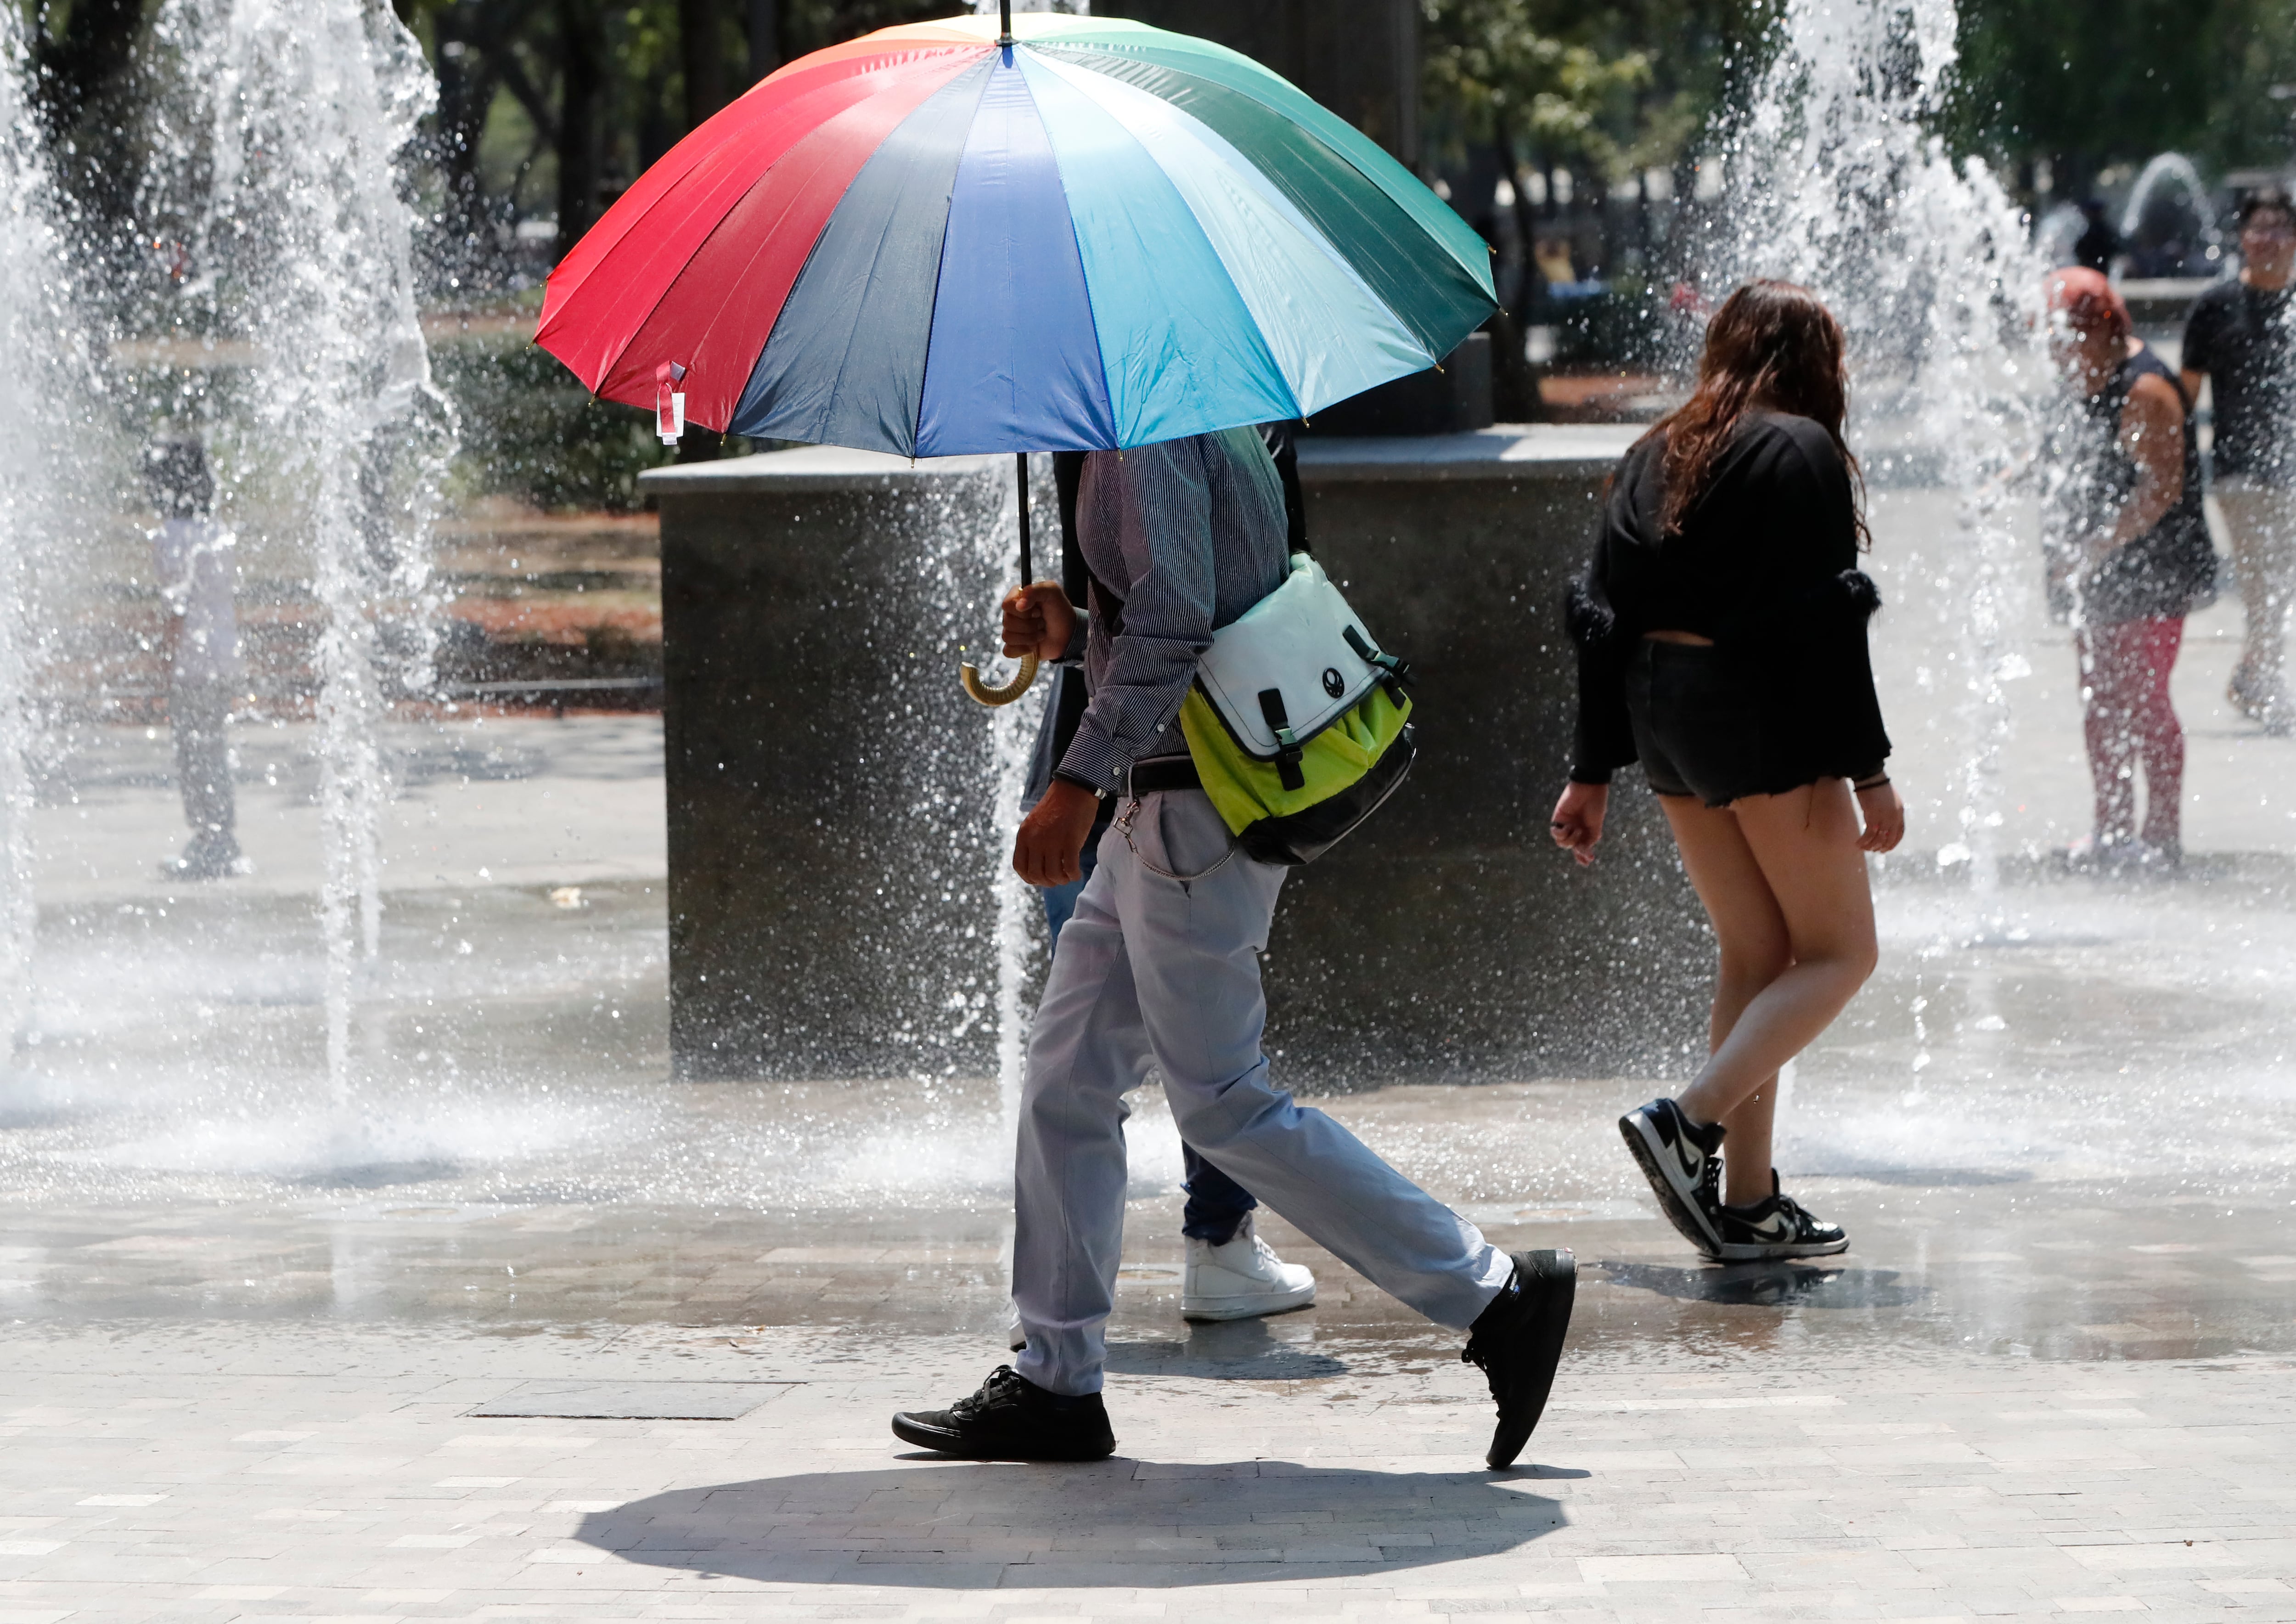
[0,498,2296,1622]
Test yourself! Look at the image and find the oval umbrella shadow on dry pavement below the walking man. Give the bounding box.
[583,1456,1564,1590]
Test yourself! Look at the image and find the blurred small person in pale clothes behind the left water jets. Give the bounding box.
[145,436,248,880]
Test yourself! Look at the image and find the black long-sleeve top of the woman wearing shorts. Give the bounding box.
[1568,411,1890,790]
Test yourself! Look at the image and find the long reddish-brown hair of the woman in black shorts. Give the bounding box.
[1644,278,1874,547]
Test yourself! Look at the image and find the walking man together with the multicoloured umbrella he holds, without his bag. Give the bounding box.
[535,11,1575,1466]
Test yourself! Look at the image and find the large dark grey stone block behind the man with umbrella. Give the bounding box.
[645,427,1713,1089]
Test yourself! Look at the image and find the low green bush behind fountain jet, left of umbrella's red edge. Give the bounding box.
[432,342,670,512]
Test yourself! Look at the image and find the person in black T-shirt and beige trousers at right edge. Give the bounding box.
[2181,186,2296,733]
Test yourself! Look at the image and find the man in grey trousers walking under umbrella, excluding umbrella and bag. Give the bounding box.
[893,429,1575,1466]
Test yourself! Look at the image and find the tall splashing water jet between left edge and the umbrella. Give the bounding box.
[154,0,452,1105]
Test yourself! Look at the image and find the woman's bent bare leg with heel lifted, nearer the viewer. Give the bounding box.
[1669,778,1876,1144]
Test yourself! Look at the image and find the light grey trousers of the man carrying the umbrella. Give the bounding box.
[1013,790,1513,1394]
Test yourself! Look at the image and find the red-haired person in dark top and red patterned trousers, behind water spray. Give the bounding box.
[2048,266,2216,868]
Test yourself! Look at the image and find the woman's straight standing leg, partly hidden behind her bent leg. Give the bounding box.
[1658,795,1793,1206]
